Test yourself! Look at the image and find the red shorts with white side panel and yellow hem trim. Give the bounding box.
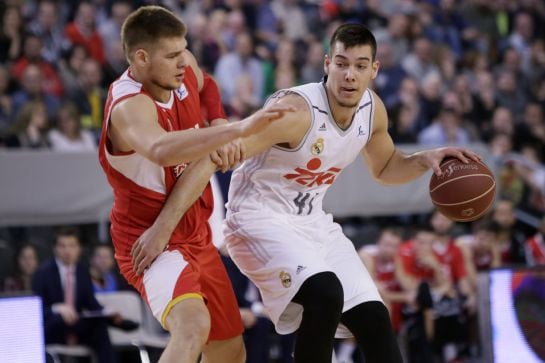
[112,236,244,340]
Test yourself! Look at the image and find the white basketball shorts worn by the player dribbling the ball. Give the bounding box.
[224,211,382,338]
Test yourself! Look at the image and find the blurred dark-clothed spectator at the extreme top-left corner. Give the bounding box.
[0,5,23,63]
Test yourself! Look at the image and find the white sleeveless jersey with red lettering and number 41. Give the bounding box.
[227,83,375,216]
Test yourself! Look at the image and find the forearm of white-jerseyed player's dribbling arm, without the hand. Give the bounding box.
[377,150,429,185]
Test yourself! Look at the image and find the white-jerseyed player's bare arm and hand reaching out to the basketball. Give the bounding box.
[362,93,480,184]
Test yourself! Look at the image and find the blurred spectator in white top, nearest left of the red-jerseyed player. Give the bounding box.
[48,103,96,152]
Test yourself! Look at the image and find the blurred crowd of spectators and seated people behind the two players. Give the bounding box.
[0,0,545,362]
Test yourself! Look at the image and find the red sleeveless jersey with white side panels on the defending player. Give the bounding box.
[99,67,213,261]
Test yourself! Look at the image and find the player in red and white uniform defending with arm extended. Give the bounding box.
[99,6,290,363]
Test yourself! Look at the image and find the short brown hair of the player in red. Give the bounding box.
[121,5,187,58]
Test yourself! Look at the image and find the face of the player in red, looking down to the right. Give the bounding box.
[149,37,187,90]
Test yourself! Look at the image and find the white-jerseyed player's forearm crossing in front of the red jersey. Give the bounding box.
[154,156,216,237]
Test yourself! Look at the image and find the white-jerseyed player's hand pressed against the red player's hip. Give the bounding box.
[131,224,170,276]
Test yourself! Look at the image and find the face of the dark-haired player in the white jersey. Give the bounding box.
[324,42,379,107]
